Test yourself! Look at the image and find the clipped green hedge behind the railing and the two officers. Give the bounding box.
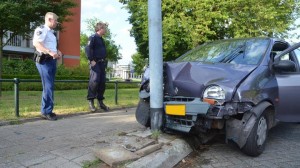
[1,59,139,91]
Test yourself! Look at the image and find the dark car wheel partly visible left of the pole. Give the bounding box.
[135,99,150,127]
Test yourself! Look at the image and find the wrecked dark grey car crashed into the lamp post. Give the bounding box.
[136,38,300,156]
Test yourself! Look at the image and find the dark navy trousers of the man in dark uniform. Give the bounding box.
[87,62,106,100]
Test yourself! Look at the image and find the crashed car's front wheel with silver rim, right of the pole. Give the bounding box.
[242,112,269,156]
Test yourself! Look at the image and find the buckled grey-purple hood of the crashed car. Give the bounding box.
[164,62,256,99]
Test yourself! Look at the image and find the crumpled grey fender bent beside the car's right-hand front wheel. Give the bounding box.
[226,101,272,148]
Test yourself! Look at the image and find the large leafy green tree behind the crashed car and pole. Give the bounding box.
[119,0,299,61]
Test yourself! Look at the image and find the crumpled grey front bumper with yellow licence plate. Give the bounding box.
[164,97,253,133]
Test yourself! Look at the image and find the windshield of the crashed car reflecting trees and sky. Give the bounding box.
[175,38,269,65]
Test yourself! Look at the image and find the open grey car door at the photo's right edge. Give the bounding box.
[273,43,300,122]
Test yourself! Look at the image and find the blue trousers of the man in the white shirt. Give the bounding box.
[36,59,56,114]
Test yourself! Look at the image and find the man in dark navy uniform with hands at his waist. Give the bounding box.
[86,22,109,112]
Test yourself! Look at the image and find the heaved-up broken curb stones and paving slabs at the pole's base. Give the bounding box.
[94,130,192,168]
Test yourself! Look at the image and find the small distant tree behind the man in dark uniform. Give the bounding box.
[80,18,122,65]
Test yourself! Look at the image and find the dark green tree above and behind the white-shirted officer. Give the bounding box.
[0,0,77,95]
